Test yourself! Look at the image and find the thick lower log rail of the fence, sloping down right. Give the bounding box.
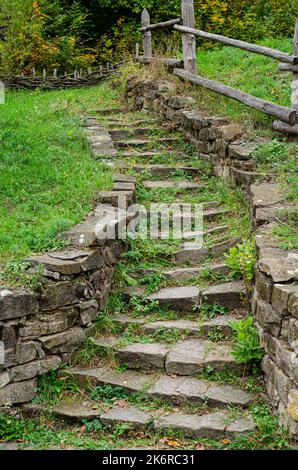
[174,69,297,125]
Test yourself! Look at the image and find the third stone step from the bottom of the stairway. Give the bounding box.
[91,336,244,376]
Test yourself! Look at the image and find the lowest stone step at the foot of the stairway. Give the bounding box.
[42,401,255,439]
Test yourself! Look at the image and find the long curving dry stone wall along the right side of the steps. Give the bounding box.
[127,80,298,436]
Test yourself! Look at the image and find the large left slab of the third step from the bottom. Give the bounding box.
[116,343,169,369]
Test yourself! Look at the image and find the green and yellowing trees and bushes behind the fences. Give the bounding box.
[0,0,297,72]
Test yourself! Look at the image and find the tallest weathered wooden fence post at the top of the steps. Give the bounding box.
[181,0,198,75]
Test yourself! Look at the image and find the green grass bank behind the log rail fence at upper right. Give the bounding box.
[176,39,293,136]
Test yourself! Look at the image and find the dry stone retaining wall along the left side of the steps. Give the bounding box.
[0,118,135,406]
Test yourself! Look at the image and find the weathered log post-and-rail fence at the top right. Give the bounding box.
[136,0,298,134]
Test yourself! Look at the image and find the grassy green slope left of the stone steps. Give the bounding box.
[0,86,117,263]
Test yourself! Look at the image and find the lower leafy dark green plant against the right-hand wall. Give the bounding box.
[229,316,264,367]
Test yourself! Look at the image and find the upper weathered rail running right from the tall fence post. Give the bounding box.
[174,25,298,65]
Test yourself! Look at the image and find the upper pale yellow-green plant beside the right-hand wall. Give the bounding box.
[225,240,257,283]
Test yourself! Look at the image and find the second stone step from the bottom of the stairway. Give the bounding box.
[64,368,253,408]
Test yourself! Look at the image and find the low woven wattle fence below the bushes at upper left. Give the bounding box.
[0,62,124,90]
